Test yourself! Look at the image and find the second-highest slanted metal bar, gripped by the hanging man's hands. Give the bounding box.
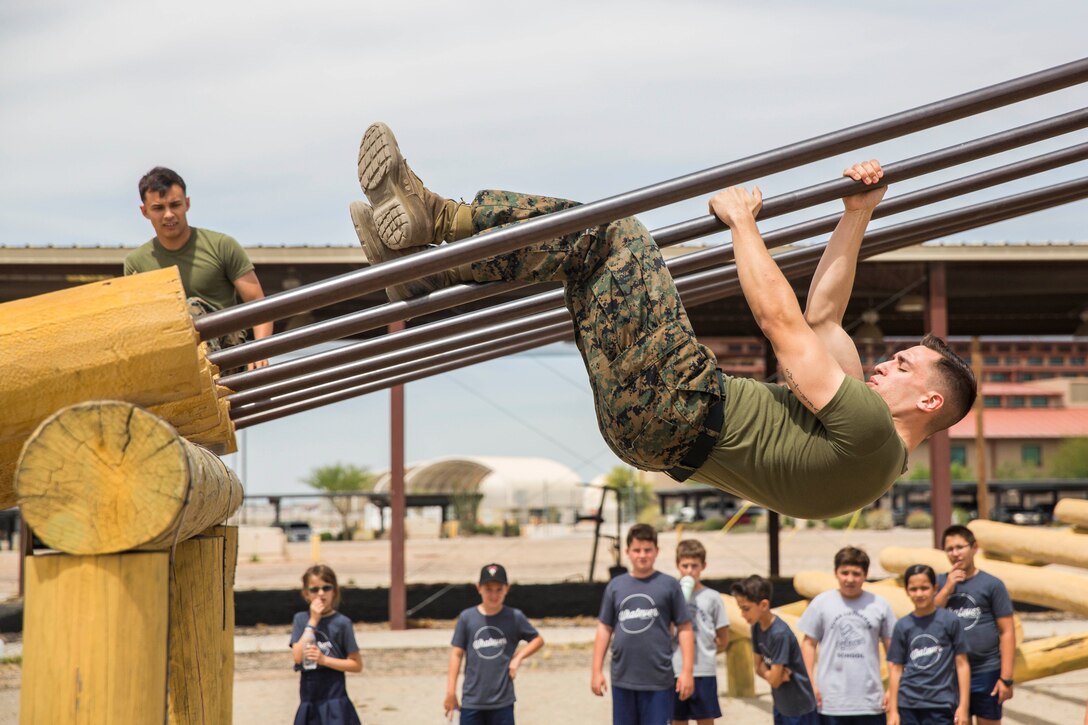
[209,109,1088,370]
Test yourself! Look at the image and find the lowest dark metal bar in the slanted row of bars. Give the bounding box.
[235,177,1088,429]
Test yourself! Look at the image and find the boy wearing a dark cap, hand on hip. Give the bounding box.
[443,564,544,725]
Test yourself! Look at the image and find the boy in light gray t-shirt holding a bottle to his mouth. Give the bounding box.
[672,539,729,725]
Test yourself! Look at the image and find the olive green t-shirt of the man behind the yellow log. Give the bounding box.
[125,226,254,309]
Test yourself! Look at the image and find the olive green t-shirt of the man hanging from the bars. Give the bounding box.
[691,376,907,518]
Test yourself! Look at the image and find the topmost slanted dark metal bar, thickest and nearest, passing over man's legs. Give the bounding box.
[195,59,1088,340]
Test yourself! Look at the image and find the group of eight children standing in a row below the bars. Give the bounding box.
[290,524,1015,725]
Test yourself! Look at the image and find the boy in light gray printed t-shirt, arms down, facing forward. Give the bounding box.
[798,546,895,725]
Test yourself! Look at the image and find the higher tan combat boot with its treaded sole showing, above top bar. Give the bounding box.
[359,123,474,249]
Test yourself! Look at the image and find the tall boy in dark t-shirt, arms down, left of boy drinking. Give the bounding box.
[590,524,695,725]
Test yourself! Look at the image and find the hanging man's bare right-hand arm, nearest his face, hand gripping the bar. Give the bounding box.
[805,159,887,380]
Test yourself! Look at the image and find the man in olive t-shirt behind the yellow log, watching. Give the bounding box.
[125,167,272,370]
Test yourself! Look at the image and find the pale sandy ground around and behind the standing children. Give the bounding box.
[0,529,1088,725]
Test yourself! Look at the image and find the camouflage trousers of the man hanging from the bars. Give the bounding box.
[472,191,722,470]
